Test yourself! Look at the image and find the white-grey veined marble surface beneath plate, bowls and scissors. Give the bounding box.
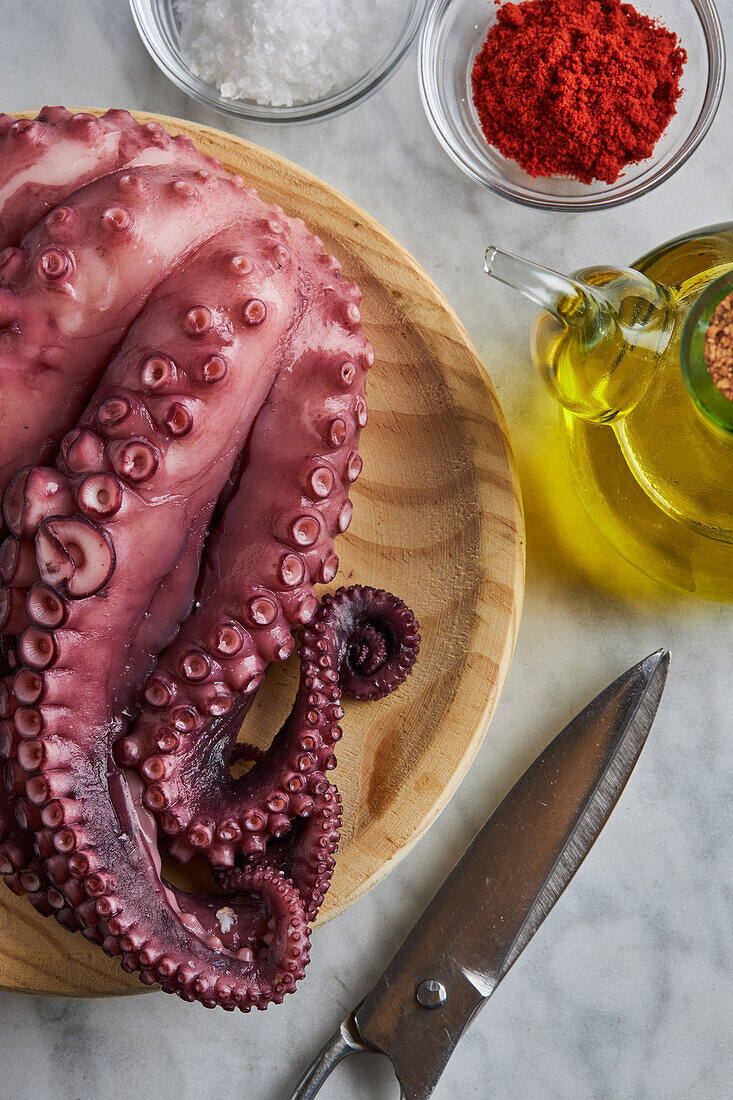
[0,0,733,1100]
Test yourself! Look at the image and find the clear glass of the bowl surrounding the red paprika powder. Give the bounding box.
[419,0,725,211]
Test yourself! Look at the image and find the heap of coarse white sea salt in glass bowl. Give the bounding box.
[175,0,394,107]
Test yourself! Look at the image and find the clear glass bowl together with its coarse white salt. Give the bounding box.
[130,0,426,122]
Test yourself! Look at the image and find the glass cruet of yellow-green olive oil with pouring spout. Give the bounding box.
[485,223,733,601]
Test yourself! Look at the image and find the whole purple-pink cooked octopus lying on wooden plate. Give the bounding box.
[0,108,419,1012]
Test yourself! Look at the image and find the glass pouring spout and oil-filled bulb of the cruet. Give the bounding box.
[484,245,676,424]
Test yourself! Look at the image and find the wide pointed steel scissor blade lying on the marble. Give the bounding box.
[354,650,669,1100]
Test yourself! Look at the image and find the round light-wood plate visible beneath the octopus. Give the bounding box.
[0,112,524,996]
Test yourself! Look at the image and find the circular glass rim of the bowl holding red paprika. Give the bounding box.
[418,0,726,213]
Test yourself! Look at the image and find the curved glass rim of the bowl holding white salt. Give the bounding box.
[130,0,428,125]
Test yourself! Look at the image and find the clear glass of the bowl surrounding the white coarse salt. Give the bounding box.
[130,0,426,122]
